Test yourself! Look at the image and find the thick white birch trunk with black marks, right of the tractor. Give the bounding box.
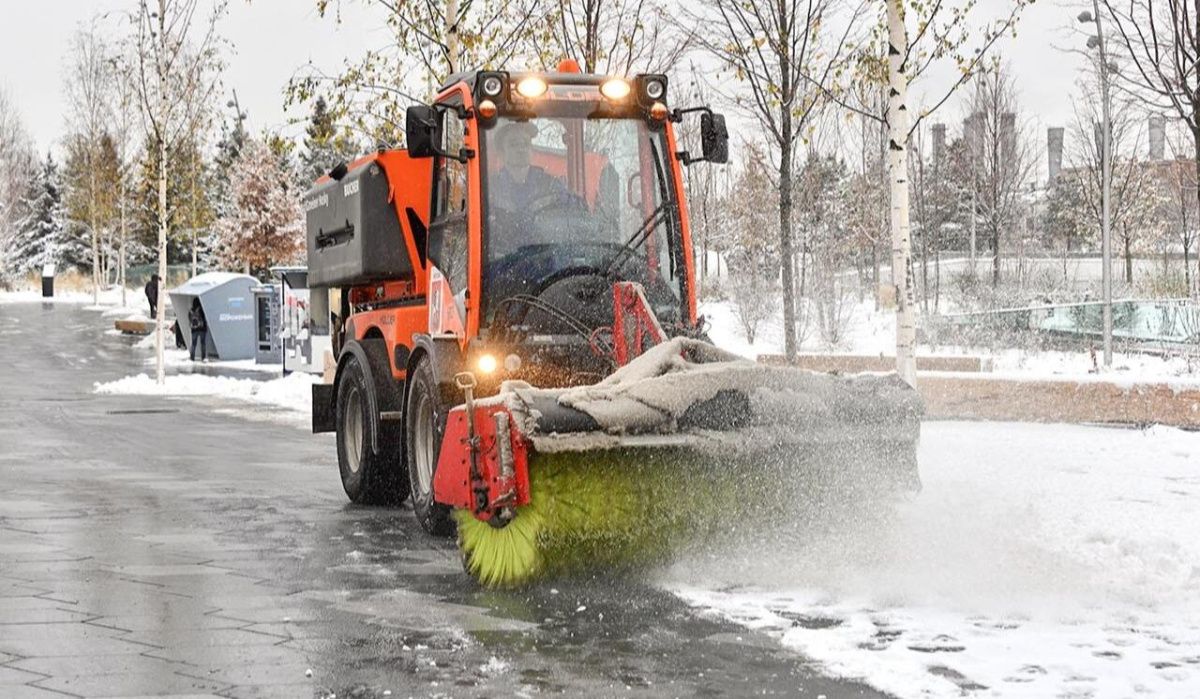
[887,0,917,386]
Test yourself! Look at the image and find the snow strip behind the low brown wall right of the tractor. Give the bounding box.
[700,301,1200,386]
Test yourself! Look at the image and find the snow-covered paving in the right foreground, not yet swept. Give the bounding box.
[665,423,1200,698]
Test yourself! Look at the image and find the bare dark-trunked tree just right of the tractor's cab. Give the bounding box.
[691,0,865,359]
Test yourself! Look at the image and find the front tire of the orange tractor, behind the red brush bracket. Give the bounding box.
[404,358,455,537]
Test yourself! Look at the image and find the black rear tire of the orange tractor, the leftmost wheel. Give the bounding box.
[336,354,408,506]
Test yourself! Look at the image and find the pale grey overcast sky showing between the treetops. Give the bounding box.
[0,0,1082,159]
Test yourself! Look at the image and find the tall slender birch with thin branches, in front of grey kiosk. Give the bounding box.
[134,0,226,383]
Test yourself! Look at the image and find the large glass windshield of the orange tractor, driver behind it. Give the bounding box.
[482,109,684,327]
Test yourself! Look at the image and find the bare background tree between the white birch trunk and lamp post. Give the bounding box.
[965,64,1037,287]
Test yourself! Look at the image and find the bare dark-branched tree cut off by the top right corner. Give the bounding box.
[1100,0,1200,293]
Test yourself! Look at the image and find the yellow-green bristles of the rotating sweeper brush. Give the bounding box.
[455,448,744,587]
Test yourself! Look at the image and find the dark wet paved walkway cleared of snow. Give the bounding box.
[0,304,876,698]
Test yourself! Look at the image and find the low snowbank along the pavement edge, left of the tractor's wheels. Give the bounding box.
[95,372,319,413]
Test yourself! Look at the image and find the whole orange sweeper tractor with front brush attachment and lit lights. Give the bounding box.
[304,61,919,585]
